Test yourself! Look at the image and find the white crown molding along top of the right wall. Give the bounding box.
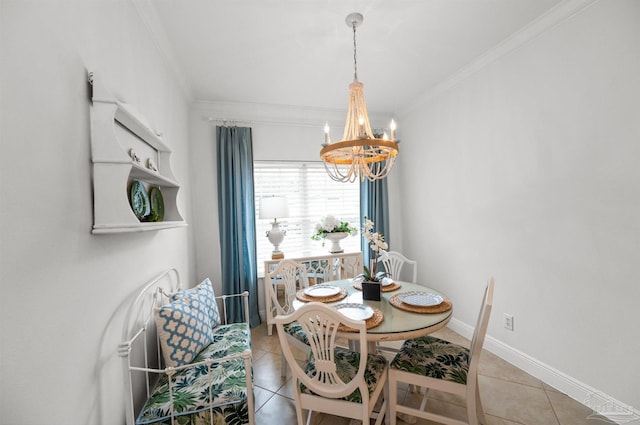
[398,0,599,117]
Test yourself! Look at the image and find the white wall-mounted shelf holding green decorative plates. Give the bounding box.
[89,73,187,234]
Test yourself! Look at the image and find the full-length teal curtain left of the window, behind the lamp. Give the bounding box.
[216,126,260,326]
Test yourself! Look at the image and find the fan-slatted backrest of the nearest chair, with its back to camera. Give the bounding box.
[275,302,368,398]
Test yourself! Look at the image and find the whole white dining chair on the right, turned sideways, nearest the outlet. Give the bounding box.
[389,278,494,425]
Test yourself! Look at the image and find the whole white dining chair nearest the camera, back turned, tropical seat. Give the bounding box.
[276,302,388,425]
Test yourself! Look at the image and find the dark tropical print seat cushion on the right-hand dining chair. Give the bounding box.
[391,336,469,384]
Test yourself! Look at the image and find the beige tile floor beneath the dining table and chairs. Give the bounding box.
[252,324,609,425]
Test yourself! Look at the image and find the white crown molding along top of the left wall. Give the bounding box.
[130,0,194,102]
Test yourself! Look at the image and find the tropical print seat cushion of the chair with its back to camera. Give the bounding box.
[300,347,387,403]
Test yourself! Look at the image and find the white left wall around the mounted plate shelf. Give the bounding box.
[0,0,195,425]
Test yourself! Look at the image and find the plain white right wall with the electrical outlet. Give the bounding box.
[398,0,640,409]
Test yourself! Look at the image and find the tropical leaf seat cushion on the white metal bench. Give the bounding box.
[136,323,251,425]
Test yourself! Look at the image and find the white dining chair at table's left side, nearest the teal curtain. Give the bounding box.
[265,260,309,377]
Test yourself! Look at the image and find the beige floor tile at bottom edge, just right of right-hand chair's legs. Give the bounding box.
[480,376,559,425]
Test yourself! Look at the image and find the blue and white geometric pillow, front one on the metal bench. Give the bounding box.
[155,299,213,367]
